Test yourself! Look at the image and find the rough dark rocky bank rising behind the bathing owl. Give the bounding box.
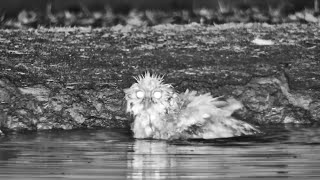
[0,23,320,133]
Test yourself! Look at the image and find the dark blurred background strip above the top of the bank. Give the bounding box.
[0,0,319,26]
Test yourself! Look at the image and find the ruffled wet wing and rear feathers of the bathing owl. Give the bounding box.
[177,91,260,139]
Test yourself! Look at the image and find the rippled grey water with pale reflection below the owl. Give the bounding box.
[0,126,320,179]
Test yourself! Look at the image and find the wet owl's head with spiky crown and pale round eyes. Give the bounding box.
[124,72,174,115]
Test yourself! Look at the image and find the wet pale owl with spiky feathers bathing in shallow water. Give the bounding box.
[124,72,260,140]
